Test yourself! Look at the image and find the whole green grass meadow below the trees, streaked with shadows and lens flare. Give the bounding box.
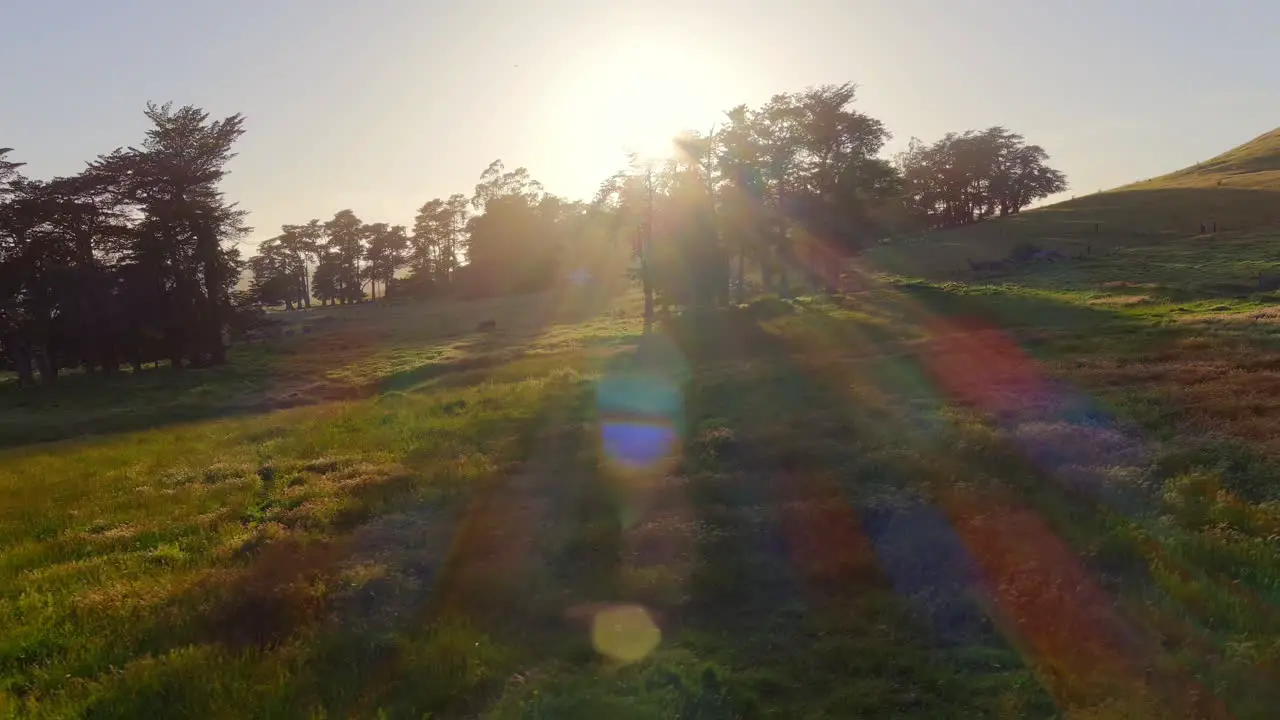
[12,236,1280,719]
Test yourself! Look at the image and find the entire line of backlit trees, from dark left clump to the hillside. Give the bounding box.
[0,83,1065,383]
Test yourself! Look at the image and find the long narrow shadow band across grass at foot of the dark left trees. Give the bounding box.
[0,291,630,447]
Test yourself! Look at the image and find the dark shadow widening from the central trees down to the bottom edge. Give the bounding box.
[650,314,1051,717]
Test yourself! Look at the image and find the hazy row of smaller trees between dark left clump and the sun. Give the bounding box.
[248,160,621,309]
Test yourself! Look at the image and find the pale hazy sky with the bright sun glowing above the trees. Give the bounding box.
[0,0,1280,246]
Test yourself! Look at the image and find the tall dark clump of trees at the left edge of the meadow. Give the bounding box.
[0,105,248,383]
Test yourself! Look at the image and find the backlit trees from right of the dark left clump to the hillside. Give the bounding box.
[251,83,1065,320]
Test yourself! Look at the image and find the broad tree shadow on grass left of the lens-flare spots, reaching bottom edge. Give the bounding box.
[63,371,618,717]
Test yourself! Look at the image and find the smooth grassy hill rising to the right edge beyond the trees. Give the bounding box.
[868,128,1280,275]
